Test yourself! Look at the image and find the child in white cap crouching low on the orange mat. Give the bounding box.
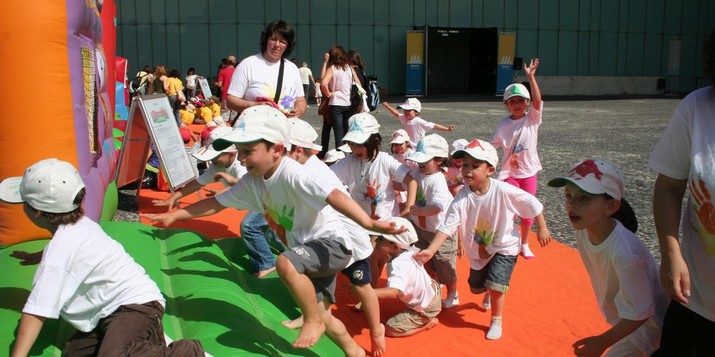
[375,217,442,337]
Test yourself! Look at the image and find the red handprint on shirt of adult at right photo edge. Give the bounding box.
[688,175,715,257]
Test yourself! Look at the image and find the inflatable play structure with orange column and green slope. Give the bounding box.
[0,0,340,356]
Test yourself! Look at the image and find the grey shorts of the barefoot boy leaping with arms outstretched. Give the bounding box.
[282,238,352,303]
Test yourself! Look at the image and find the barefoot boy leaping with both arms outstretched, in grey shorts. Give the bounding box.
[144,105,400,356]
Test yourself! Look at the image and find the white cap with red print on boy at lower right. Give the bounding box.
[549,159,626,200]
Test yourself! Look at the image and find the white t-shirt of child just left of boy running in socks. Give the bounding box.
[410,167,452,233]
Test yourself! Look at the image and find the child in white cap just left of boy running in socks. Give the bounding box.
[407,134,459,309]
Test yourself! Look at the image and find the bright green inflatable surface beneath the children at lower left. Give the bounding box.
[0,222,343,357]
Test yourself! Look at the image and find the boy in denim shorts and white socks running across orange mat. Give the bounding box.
[415,139,551,340]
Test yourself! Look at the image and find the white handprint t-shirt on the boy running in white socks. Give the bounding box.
[437,178,544,270]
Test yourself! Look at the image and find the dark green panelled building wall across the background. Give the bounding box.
[117,0,715,94]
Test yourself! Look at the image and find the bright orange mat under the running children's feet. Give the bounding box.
[139,190,608,356]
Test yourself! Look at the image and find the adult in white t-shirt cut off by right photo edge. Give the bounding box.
[648,31,715,357]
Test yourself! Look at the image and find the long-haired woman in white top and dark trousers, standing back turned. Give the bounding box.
[318,45,360,158]
